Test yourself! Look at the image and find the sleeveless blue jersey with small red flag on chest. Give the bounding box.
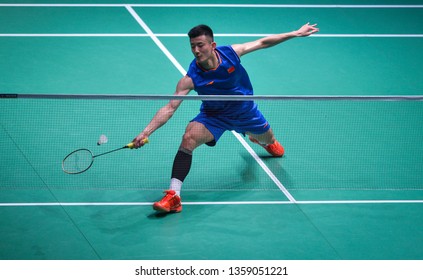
[187,46,256,117]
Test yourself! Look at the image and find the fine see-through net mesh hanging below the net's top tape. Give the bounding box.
[0,98,423,191]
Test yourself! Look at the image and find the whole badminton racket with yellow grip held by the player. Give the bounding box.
[62,138,148,174]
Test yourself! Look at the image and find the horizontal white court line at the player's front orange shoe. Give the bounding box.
[0,200,423,207]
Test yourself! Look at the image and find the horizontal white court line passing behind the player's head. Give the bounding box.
[0,33,423,38]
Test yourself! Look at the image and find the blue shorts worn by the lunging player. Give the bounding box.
[191,107,270,146]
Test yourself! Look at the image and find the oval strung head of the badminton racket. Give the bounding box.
[62,149,94,174]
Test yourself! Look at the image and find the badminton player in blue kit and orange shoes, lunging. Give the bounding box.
[133,23,319,212]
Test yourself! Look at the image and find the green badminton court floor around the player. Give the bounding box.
[0,0,423,260]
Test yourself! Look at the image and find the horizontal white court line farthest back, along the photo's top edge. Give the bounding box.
[0,3,423,9]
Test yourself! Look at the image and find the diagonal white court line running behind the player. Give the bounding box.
[126,5,295,202]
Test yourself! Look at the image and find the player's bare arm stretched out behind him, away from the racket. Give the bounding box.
[232,23,319,57]
